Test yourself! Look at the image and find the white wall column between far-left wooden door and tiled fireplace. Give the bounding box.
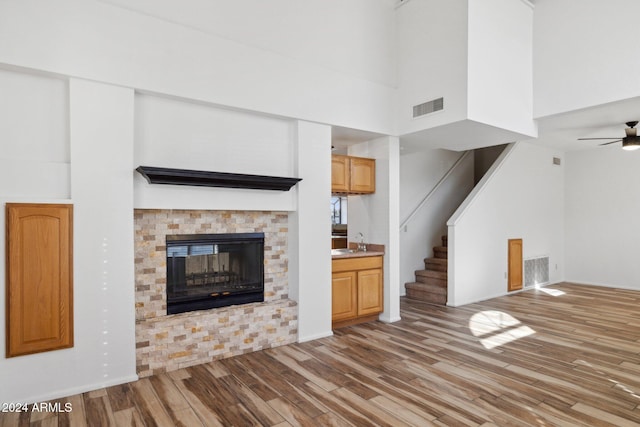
[67,79,137,389]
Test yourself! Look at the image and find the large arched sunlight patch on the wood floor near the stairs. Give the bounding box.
[469,310,536,349]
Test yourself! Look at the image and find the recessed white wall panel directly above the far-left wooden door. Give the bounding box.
[0,69,71,199]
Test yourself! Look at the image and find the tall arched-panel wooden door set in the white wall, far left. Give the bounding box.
[6,203,73,357]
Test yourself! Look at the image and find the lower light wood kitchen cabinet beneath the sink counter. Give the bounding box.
[331,256,383,328]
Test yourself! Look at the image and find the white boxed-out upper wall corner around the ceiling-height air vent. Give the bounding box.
[396,0,537,151]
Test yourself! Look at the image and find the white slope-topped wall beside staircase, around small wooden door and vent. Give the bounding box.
[448,142,565,306]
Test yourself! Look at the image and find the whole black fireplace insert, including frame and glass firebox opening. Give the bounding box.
[166,233,264,314]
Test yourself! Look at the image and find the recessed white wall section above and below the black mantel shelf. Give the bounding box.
[134,95,298,211]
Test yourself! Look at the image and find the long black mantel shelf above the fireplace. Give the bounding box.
[136,166,302,191]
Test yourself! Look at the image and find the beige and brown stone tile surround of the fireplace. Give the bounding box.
[134,209,298,377]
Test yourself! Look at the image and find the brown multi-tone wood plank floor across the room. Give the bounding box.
[0,284,640,427]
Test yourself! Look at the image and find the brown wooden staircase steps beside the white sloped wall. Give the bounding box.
[404,236,448,305]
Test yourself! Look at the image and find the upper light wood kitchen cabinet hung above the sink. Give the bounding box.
[331,154,376,194]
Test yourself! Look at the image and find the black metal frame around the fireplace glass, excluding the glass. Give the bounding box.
[166,233,264,314]
